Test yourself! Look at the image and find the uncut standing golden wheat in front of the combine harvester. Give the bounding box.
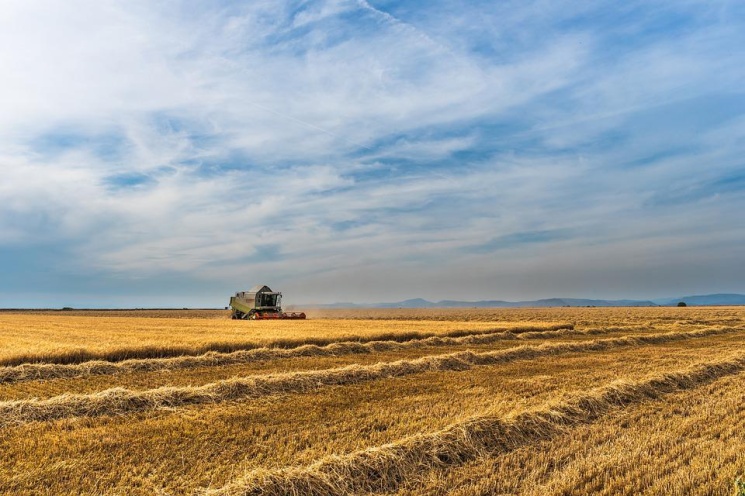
[0,313,560,365]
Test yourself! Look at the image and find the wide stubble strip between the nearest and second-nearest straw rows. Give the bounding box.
[0,335,742,495]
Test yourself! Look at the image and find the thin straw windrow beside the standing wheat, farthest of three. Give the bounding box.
[0,327,648,384]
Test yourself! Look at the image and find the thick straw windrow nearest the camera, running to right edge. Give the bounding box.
[202,352,745,496]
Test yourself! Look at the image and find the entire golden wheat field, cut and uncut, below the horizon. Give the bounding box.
[0,307,745,496]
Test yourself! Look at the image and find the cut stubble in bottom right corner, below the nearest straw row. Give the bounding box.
[396,374,745,496]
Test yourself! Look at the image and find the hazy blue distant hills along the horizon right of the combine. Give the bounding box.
[305,294,745,308]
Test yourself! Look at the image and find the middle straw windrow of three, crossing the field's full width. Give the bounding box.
[0,328,742,427]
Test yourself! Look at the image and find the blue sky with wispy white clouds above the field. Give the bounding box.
[0,0,745,307]
